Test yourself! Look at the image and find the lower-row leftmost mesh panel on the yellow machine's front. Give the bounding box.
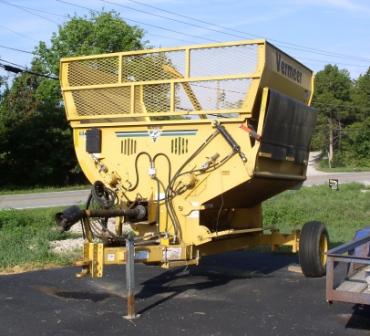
[72,87,131,116]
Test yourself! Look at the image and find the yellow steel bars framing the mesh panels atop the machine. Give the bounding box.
[61,40,313,127]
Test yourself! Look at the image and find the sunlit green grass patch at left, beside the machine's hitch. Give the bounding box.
[0,208,80,272]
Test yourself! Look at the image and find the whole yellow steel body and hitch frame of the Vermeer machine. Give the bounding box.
[61,40,313,277]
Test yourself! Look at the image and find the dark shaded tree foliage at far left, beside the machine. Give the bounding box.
[0,70,75,185]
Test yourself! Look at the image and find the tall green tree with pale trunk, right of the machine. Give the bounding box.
[313,65,355,165]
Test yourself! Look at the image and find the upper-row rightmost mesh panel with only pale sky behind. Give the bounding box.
[190,45,258,77]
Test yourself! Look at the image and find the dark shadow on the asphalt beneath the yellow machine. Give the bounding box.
[136,252,298,314]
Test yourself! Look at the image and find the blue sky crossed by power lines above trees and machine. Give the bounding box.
[0,0,370,78]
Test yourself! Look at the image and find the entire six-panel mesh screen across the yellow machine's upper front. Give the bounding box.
[62,43,259,120]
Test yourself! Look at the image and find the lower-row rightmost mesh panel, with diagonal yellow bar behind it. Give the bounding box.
[175,79,251,112]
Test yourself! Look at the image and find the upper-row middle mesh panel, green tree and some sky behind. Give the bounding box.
[122,50,185,82]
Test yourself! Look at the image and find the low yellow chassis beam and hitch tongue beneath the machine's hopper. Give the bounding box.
[76,230,300,278]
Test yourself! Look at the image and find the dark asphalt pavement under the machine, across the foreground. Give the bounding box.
[0,252,370,336]
